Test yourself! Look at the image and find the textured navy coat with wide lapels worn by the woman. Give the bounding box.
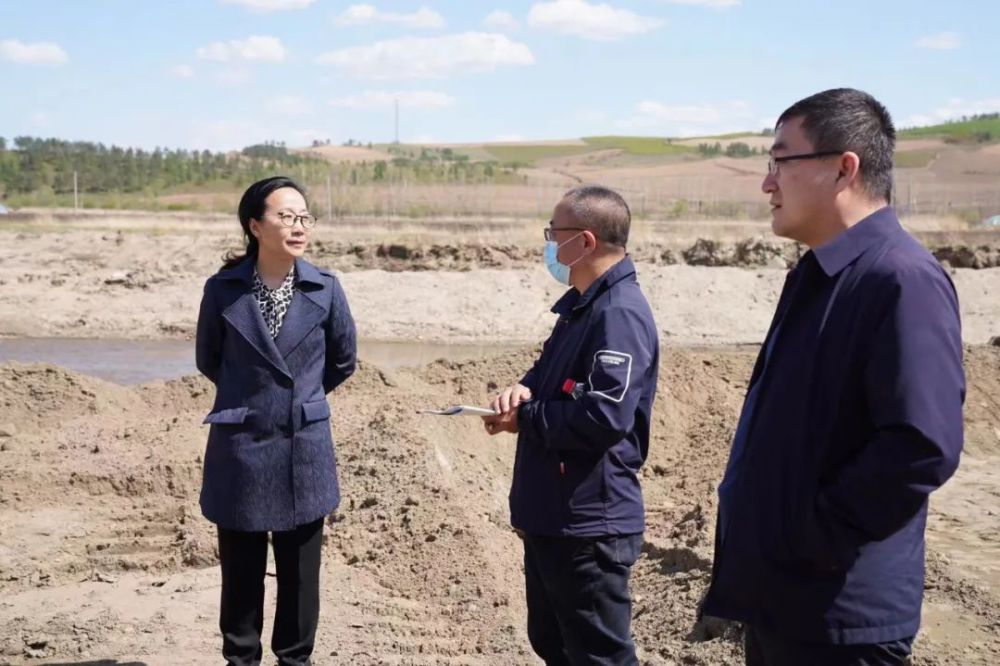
[196,256,357,531]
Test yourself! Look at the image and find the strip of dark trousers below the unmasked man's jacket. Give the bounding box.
[743,625,913,666]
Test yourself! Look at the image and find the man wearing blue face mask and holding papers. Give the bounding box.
[483,186,659,666]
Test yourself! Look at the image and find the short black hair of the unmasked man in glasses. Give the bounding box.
[775,88,896,202]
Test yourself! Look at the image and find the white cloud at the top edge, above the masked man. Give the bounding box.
[528,0,664,42]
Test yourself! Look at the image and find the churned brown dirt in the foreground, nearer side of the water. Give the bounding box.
[0,347,1000,666]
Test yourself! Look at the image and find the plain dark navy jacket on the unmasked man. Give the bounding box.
[703,207,965,644]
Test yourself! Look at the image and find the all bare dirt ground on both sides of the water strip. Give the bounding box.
[0,214,1000,666]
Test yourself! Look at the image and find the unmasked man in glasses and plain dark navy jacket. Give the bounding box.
[703,89,965,666]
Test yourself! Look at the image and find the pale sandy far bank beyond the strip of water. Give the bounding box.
[0,217,1000,344]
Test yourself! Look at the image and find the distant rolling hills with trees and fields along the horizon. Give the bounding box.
[0,113,1000,219]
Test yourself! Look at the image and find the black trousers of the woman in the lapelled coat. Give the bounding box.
[219,518,323,666]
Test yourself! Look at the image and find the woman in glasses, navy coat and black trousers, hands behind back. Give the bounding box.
[196,176,357,666]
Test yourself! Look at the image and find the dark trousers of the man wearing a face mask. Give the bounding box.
[524,534,642,666]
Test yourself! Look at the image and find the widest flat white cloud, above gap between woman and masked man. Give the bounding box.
[316,32,535,79]
